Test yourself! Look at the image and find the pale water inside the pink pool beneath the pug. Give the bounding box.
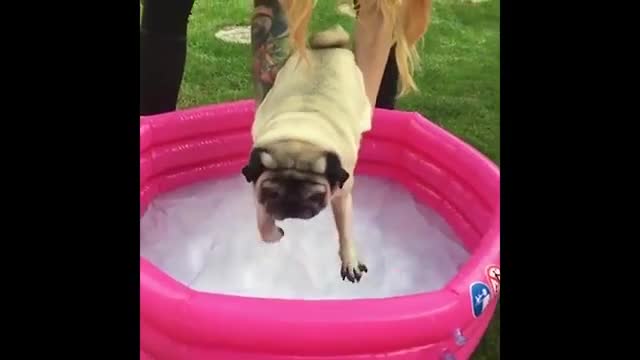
[140,176,469,299]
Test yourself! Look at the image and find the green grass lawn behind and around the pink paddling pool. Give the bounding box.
[179,0,500,360]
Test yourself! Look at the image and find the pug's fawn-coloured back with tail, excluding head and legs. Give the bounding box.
[253,27,372,177]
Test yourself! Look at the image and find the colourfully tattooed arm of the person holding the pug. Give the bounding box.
[251,0,289,104]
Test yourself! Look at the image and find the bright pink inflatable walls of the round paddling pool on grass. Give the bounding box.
[140,101,500,360]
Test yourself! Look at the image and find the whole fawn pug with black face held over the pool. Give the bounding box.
[242,26,373,283]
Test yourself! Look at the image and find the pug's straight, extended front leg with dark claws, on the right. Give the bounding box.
[331,193,368,282]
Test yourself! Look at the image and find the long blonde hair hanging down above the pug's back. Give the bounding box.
[281,0,431,96]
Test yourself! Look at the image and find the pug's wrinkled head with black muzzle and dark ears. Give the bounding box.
[242,142,349,220]
